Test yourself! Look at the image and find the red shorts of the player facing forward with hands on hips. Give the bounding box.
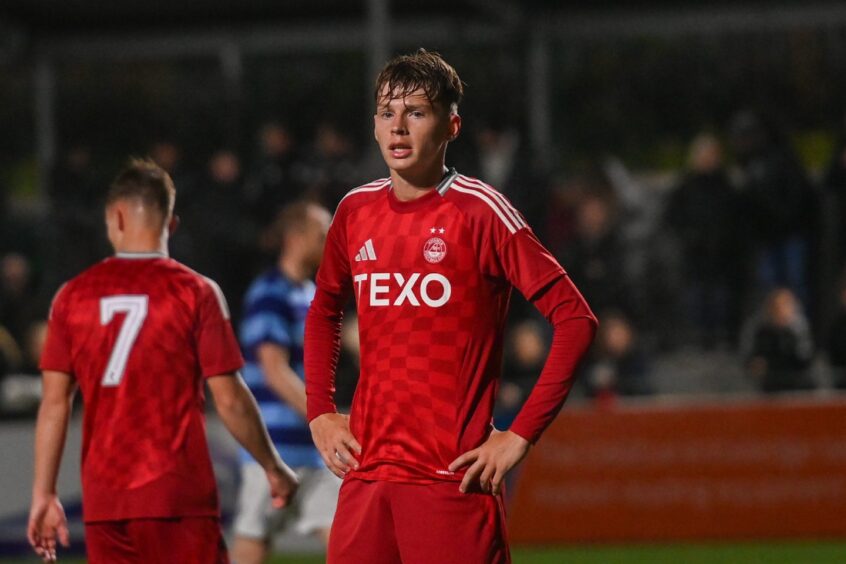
[326,479,511,564]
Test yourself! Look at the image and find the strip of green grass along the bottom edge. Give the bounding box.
[6,541,846,564]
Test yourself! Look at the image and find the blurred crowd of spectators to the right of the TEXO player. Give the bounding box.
[470,111,846,400]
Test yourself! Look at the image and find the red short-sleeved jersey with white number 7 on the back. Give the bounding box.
[41,253,243,522]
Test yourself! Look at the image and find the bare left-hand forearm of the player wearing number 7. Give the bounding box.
[32,396,73,495]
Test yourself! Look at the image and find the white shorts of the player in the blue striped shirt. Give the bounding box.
[234,462,341,540]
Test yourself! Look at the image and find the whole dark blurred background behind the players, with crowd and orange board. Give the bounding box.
[0,0,846,562]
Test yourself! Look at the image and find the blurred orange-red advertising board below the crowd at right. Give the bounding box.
[509,397,846,543]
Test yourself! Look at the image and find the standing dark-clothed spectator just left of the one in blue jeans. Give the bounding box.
[665,134,743,348]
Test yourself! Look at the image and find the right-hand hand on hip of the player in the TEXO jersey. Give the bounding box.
[449,429,531,495]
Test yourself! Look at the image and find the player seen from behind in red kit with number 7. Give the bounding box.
[28,160,297,563]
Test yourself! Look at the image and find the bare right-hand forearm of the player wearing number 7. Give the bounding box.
[212,377,281,468]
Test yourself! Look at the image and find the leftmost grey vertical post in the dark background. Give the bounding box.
[33,57,56,198]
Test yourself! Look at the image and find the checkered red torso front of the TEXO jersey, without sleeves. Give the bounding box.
[347,194,507,479]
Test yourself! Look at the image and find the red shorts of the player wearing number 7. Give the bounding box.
[85,517,229,564]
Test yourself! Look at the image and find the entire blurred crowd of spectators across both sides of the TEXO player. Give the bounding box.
[0,112,846,421]
